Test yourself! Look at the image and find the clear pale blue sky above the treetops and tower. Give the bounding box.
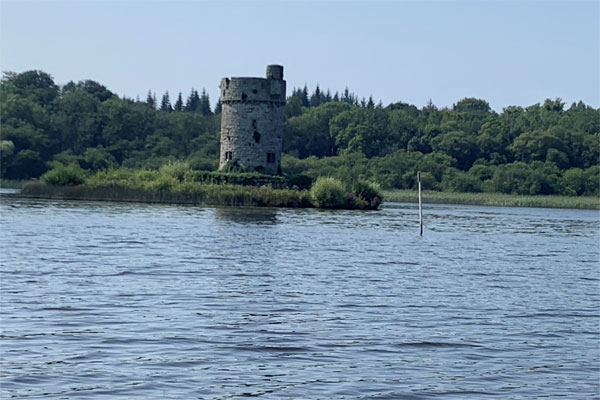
[0,0,600,111]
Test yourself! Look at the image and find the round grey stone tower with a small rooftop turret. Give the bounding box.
[219,65,285,175]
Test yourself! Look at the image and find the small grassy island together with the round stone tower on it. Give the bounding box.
[15,65,383,210]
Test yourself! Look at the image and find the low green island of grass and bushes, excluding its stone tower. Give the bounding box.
[21,162,383,210]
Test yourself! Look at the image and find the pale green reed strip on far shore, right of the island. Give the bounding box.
[383,190,600,210]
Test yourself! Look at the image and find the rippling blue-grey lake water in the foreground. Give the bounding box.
[0,197,600,399]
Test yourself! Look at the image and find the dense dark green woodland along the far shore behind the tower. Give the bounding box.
[0,71,600,195]
